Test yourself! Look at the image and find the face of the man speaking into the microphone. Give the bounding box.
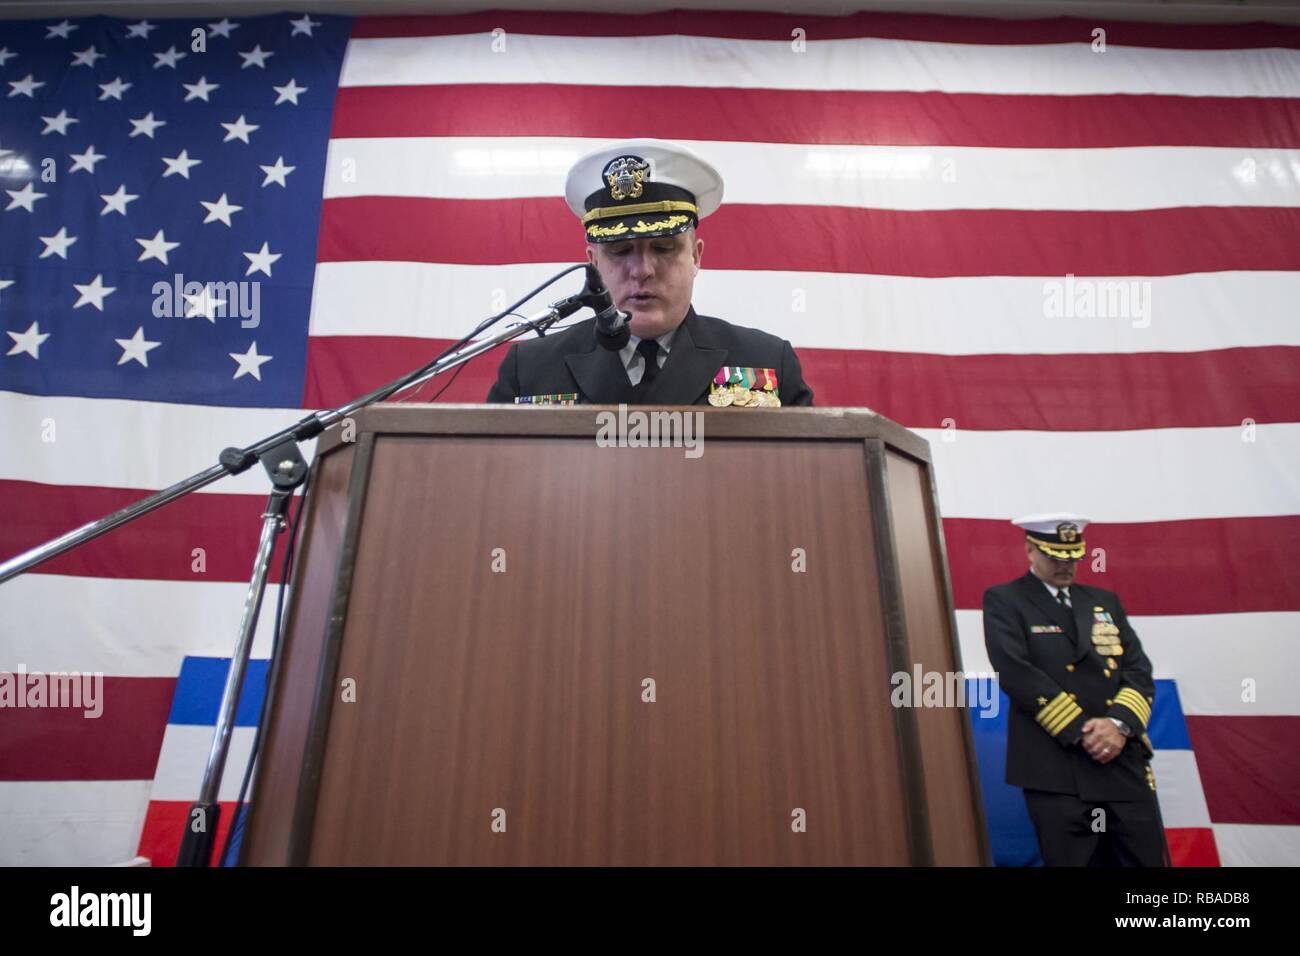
[586,228,705,338]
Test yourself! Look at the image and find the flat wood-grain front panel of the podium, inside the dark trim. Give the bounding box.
[306,434,909,865]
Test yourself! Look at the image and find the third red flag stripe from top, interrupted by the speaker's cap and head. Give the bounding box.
[317,196,1300,277]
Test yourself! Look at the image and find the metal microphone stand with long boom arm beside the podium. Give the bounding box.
[0,294,586,866]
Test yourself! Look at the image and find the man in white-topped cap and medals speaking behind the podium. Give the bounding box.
[488,139,813,408]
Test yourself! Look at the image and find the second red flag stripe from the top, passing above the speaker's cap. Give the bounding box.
[330,83,1300,150]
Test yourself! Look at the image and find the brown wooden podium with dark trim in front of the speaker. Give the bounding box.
[242,406,989,865]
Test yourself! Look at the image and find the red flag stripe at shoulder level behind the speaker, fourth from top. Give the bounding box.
[304,335,1300,432]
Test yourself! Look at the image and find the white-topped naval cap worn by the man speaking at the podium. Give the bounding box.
[564,139,723,242]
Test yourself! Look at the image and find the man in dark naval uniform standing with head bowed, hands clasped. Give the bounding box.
[984,514,1169,866]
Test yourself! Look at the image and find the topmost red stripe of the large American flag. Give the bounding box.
[352,10,1300,49]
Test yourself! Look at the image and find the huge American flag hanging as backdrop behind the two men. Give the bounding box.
[0,12,1300,865]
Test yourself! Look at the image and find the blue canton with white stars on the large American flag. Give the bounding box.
[0,14,350,407]
